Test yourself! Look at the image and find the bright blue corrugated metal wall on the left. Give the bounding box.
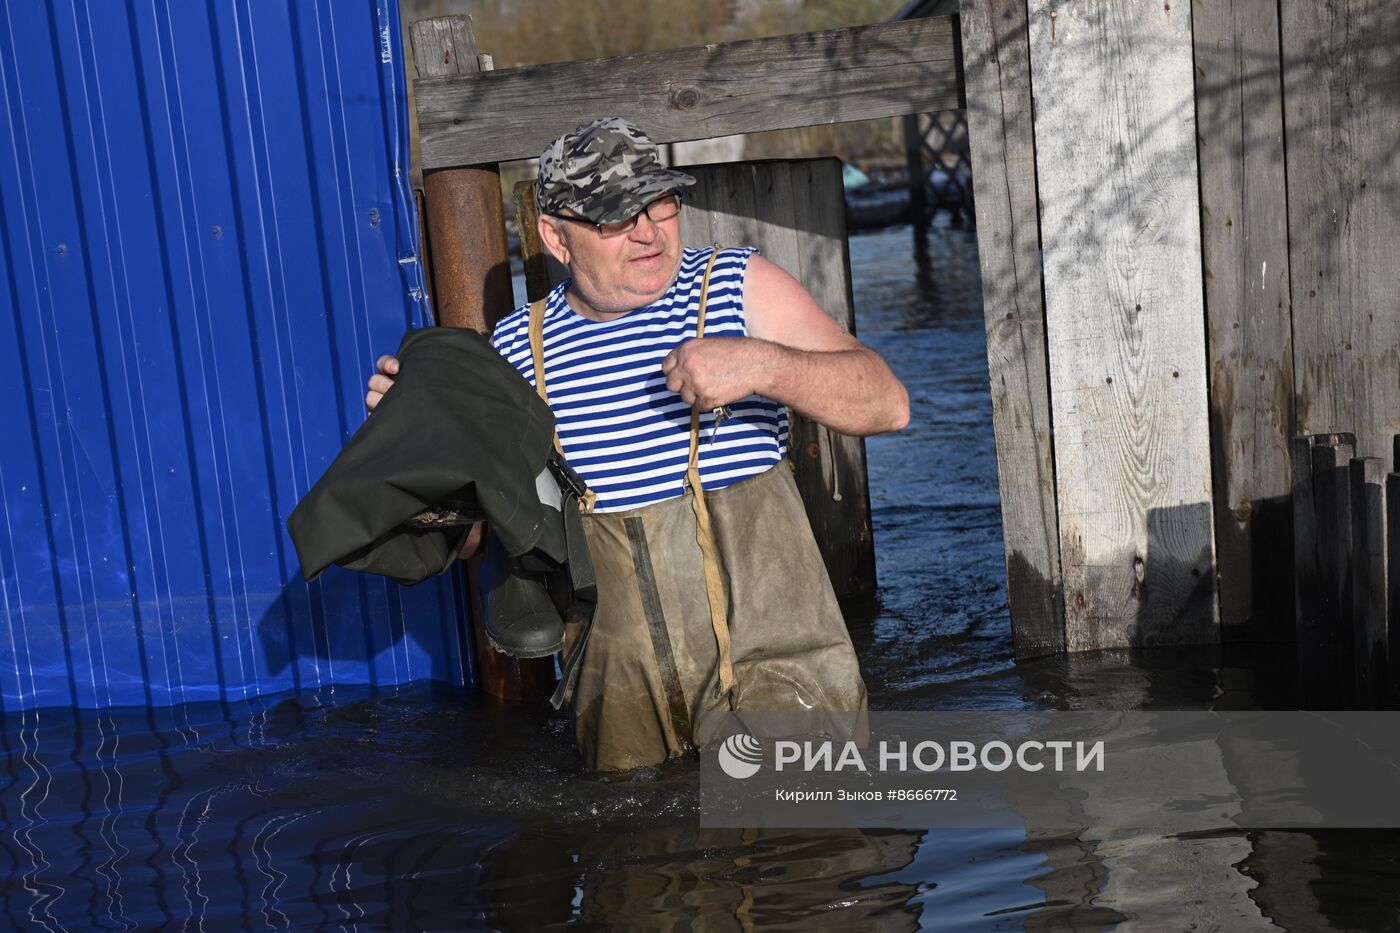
[0,0,470,709]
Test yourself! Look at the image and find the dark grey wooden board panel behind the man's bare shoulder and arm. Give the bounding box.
[517,158,875,597]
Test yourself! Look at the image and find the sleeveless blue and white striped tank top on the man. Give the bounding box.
[491,247,788,511]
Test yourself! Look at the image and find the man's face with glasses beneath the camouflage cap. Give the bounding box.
[540,191,680,319]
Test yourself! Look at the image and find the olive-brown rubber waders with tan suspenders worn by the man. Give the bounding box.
[529,249,867,770]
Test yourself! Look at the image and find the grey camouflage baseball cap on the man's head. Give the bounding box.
[535,116,696,224]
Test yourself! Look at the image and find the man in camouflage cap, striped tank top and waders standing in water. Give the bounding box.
[365,118,909,770]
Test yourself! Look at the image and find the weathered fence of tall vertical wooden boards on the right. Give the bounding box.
[962,0,1400,680]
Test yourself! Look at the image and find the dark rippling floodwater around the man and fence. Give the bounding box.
[0,219,1400,932]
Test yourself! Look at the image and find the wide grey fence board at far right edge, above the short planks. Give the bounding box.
[1280,0,1400,457]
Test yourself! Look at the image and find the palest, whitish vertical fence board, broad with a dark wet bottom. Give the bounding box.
[1029,0,1219,649]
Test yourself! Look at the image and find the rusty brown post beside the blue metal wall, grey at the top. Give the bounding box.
[410,17,554,702]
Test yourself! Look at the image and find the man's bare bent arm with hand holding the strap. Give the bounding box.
[662,255,909,436]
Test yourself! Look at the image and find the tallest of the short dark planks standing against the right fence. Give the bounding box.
[1312,434,1357,700]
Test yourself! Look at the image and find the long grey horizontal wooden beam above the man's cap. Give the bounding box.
[413,17,963,170]
